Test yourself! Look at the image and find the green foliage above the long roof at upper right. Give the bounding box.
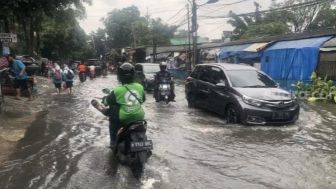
[228,0,336,40]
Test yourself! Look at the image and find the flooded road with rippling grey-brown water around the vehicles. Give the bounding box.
[0,76,336,189]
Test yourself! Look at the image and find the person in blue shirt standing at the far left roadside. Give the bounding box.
[6,54,33,100]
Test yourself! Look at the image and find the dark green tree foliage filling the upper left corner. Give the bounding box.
[0,0,91,59]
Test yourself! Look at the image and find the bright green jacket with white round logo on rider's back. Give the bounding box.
[103,83,145,124]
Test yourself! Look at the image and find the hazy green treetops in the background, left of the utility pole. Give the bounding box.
[103,6,176,48]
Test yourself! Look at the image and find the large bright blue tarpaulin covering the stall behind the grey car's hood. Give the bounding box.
[261,37,331,80]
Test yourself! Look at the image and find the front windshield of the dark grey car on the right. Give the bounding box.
[227,70,277,88]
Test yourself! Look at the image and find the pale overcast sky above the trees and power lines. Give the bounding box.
[80,0,281,39]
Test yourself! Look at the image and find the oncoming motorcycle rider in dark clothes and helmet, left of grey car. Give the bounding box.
[154,62,175,102]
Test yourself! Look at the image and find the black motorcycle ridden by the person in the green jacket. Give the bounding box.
[91,89,153,174]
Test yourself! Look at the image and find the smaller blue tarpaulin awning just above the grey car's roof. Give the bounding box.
[219,44,260,59]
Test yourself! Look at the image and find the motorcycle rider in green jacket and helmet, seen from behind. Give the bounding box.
[93,63,146,149]
